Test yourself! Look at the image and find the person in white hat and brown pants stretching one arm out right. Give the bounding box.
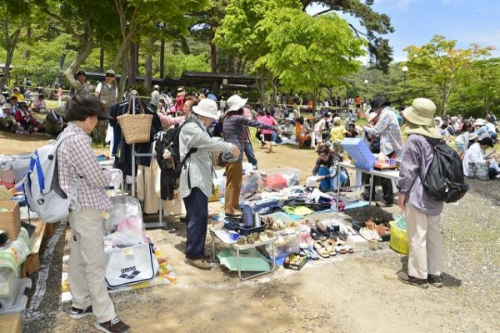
[222,95,277,216]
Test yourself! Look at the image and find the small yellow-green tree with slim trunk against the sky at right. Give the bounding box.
[404,35,493,116]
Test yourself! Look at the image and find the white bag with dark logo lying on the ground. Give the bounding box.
[106,243,159,289]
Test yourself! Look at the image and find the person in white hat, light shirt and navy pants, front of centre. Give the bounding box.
[179,98,241,269]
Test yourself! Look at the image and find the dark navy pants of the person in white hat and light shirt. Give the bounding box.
[184,187,208,259]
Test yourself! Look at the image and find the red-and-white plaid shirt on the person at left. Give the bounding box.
[57,122,111,210]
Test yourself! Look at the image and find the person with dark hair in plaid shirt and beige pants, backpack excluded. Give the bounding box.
[57,96,130,333]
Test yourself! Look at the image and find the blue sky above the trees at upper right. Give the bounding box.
[308,0,500,61]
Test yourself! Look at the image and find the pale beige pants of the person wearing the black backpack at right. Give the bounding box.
[405,204,443,279]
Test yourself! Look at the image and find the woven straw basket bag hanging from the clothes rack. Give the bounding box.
[116,98,153,145]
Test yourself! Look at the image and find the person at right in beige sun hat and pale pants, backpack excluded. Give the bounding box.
[396,98,443,289]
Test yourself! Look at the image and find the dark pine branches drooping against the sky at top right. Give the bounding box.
[301,0,394,73]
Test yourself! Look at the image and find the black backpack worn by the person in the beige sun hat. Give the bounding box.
[422,137,469,203]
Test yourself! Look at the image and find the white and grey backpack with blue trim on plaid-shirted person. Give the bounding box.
[21,133,80,223]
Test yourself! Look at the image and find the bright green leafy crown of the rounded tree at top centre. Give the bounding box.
[255,8,366,95]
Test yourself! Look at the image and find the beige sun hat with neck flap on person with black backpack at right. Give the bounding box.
[403,98,441,139]
